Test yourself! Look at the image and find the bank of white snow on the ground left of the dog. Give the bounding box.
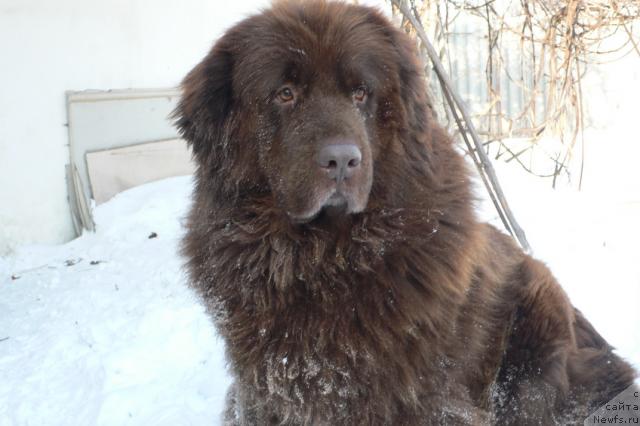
[0,177,229,426]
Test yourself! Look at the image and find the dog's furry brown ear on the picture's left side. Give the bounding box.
[171,45,233,160]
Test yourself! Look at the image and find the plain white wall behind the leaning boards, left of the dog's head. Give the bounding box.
[0,0,268,255]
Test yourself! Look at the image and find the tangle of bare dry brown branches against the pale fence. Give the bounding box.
[388,0,640,185]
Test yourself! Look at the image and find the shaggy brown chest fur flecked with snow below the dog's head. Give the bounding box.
[185,188,477,424]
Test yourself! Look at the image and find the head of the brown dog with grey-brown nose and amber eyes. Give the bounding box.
[174,1,426,222]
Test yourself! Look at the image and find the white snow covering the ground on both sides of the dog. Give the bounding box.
[0,167,640,426]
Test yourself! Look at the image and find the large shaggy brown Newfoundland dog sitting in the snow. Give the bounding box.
[175,1,634,425]
